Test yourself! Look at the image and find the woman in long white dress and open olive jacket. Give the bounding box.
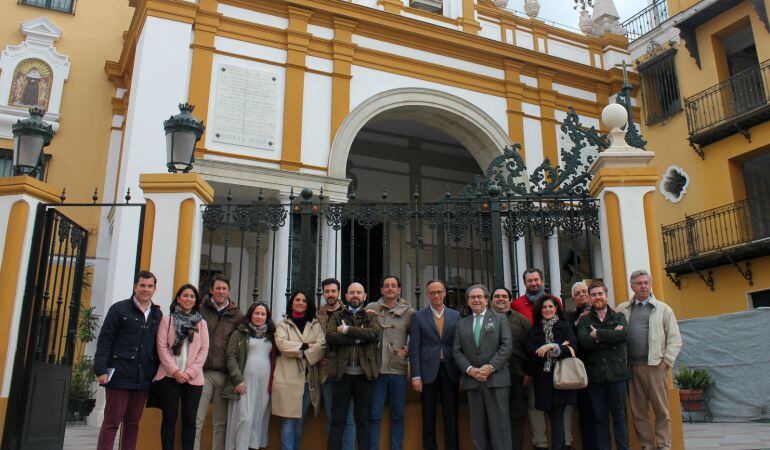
[222,302,276,450]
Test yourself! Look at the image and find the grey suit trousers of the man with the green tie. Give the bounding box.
[467,383,513,450]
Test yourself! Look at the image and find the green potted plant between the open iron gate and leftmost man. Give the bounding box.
[67,306,99,420]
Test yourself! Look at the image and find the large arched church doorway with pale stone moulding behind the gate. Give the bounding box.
[329,89,511,306]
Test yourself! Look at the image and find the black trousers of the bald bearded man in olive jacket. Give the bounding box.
[326,374,374,450]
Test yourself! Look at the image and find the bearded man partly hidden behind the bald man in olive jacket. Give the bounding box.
[317,278,356,450]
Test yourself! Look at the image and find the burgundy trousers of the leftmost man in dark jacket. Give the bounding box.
[96,388,149,450]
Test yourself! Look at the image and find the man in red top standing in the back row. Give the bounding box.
[511,268,572,450]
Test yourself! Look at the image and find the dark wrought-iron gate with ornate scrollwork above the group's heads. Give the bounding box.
[201,110,608,312]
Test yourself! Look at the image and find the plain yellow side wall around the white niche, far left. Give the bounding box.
[0,0,133,255]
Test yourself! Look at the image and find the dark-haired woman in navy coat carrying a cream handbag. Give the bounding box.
[527,295,577,450]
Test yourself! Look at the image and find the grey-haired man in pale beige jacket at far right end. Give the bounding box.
[616,270,682,450]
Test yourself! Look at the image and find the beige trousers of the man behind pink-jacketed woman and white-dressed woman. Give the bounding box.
[195,370,228,450]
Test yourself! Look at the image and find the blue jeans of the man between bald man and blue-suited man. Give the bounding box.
[372,374,406,450]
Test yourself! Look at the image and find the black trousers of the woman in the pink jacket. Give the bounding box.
[157,377,203,450]
